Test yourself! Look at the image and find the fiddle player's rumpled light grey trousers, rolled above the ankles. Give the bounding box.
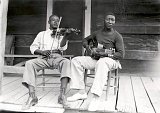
[22,58,71,88]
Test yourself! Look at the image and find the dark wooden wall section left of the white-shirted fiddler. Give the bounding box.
[7,0,47,63]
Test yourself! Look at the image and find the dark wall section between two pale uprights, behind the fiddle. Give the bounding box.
[53,0,85,56]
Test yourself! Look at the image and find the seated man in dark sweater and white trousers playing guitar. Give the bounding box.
[67,13,125,111]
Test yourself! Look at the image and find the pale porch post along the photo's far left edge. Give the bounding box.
[0,0,9,94]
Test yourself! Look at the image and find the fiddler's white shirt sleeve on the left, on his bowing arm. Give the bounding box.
[30,32,42,54]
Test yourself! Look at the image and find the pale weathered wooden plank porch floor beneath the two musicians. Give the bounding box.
[0,73,160,113]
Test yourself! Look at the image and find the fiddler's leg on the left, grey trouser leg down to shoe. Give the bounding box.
[22,58,49,109]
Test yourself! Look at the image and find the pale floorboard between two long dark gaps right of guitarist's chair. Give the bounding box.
[131,76,155,113]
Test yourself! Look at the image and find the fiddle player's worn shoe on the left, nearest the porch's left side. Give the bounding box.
[22,97,38,110]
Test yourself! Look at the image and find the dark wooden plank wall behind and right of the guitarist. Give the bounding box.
[91,0,160,72]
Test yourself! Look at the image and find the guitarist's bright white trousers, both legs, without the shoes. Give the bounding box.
[70,56,121,96]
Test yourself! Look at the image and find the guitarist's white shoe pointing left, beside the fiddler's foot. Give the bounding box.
[67,93,87,102]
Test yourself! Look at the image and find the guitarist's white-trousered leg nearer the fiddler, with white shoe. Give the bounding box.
[67,56,97,101]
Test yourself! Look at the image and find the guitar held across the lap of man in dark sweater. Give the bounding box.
[84,39,115,60]
